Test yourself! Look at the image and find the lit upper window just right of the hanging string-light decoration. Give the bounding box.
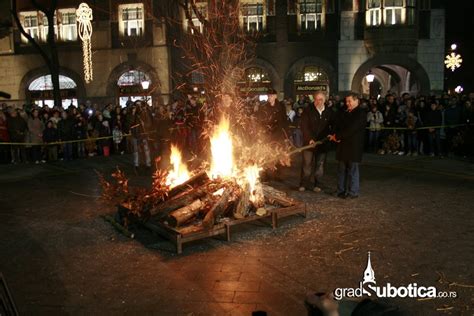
[119,3,145,36]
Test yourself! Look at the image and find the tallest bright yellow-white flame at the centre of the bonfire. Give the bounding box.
[210,118,234,179]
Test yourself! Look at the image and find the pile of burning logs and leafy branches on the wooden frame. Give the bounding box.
[100,170,295,234]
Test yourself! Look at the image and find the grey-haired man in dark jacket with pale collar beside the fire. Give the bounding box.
[299,92,334,192]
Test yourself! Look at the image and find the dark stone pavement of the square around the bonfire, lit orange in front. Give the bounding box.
[0,155,474,315]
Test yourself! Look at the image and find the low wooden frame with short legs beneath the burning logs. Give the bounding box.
[143,203,307,254]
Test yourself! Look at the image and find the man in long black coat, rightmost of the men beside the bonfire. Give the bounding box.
[330,93,367,198]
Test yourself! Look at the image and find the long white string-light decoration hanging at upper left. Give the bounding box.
[76,3,92,83]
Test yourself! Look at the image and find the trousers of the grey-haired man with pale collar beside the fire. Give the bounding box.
[300,150,326,190]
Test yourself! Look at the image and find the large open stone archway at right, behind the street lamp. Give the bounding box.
[351,55,431,95]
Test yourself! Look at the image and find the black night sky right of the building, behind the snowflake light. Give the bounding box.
[444,0,474,93]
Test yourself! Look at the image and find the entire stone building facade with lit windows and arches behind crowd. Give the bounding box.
[0,0,445,105]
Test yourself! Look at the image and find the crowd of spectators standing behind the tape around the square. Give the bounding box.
[0,90,474,166]
